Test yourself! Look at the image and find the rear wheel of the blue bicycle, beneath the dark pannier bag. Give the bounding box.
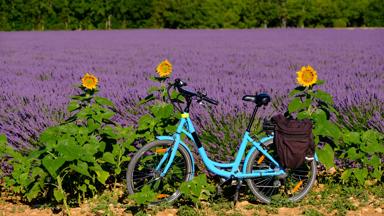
[247,140,317,203]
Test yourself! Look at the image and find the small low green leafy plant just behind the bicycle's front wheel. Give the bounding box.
[180,174,216,205]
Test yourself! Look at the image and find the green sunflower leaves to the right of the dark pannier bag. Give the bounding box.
[288,76,384,185]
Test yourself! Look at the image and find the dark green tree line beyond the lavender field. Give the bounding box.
[0,0,384,31]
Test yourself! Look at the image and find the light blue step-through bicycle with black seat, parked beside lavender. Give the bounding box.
[127,79,317,204]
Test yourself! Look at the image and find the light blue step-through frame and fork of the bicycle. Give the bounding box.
[156,113,285,179]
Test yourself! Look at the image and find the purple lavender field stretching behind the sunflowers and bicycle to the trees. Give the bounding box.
[0,29,384,147]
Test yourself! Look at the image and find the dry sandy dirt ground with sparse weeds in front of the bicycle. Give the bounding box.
[0,184,384,216]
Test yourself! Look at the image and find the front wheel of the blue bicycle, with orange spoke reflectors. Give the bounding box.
[127,140,193,205]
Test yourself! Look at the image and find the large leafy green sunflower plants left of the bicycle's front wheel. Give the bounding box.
[0,83,136,208]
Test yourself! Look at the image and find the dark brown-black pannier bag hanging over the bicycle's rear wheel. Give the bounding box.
[272,114,315,169]
